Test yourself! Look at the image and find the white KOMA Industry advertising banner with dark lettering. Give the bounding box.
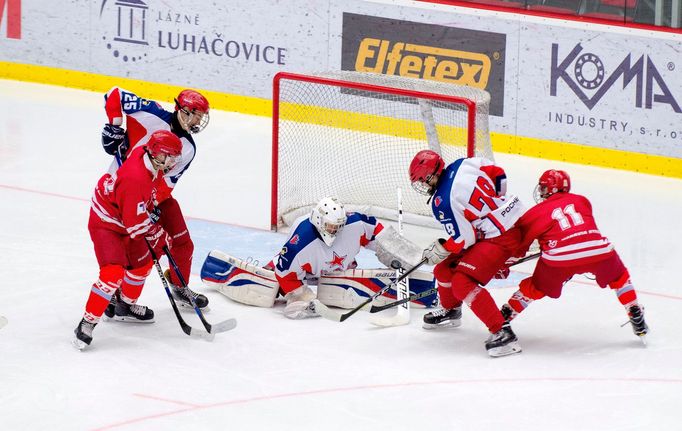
[516,24,682,158]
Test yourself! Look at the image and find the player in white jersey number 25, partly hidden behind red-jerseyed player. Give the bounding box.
[102,87,209,317]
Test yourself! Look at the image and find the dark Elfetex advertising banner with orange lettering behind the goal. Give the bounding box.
[341,13,506,117]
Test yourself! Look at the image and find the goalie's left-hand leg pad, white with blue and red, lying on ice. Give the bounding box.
[201,250,279,308]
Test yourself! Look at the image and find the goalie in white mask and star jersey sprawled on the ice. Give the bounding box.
[201,198,436,319]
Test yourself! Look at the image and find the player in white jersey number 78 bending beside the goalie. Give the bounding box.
[409,150,525,356]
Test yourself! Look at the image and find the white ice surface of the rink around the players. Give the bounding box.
[0,80,682,431]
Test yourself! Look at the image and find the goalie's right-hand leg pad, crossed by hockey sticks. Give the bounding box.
[317,269,438,309]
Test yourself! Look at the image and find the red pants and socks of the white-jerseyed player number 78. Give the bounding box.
[433,228,521,333]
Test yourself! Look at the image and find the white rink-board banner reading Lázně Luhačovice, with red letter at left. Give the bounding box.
[0,0,328,98]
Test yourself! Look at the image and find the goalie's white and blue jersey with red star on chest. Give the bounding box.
[275,212,383,294]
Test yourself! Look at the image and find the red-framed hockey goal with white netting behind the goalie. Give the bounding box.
[271,71,493,230]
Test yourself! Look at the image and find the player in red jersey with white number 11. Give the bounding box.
[502,169,649,337]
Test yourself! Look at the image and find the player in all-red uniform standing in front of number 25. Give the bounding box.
[74,130,182,350]
